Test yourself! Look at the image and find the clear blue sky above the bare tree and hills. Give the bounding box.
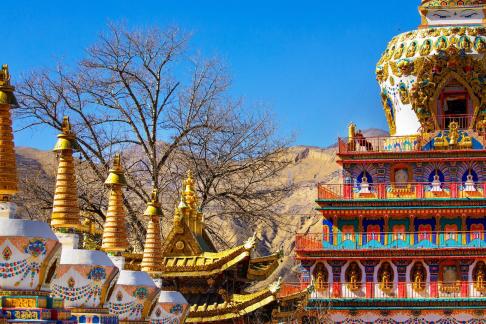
[4,0,419,149]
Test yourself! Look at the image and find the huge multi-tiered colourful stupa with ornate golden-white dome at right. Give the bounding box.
[290,0,486,323]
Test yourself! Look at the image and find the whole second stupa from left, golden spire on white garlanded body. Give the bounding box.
[51,117,119,323]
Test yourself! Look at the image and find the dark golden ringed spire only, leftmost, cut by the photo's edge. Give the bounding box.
[0,64,17,201]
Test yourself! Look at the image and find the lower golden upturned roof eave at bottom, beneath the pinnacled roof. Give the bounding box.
[186,279,281,323]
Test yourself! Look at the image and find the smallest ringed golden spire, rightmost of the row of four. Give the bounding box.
[141,189,162,273]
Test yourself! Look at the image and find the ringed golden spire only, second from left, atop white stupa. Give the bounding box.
[51,117,81,230]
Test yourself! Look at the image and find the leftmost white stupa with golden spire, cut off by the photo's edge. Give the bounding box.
[0,65,71,323]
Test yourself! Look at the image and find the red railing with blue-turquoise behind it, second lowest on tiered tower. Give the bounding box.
[295,230,486,255]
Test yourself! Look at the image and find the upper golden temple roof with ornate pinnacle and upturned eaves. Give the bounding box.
[157,172,281,280]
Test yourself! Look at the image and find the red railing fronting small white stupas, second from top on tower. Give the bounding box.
[317,182,486,200]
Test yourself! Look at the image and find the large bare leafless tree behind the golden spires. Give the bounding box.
[16,25,292,248]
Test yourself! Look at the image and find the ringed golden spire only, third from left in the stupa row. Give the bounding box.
[101,154,128,254]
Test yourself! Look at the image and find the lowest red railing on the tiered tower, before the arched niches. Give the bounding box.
[310,280,486,299]
